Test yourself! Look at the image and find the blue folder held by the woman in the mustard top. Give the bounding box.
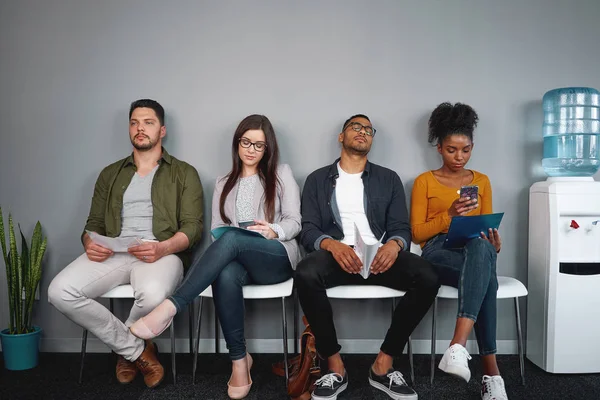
[444,213,504,249]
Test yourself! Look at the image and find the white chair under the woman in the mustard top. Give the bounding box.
[411,243,527,385]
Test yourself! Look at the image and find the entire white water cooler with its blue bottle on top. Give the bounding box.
[527,87,600,373]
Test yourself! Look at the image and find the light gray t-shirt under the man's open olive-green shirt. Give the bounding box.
[119,165,158,240]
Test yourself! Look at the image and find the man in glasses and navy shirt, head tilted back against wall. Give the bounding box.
[296,114,439,400]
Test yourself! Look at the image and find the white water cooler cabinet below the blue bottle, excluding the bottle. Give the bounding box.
[527,177,600,373]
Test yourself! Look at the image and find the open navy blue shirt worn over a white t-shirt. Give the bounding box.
[300,158,412,253]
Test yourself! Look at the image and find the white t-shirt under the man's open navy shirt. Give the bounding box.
[335,163,377,246]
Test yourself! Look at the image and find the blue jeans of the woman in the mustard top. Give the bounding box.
[422,234,498,355]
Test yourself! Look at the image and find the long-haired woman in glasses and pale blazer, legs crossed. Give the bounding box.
[131,115,301,399]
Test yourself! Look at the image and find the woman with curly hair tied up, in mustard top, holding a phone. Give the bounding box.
[411,103,508,400]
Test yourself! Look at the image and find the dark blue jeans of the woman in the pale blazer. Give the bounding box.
[169,231,292,360]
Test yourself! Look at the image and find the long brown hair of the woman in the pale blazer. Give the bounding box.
[219,114,279,224]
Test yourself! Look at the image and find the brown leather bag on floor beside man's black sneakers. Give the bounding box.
[272,317,321,400]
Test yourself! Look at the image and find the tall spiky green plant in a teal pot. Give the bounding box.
[0,207,47,370]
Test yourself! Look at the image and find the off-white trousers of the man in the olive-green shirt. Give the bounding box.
[48,253,183,361]
